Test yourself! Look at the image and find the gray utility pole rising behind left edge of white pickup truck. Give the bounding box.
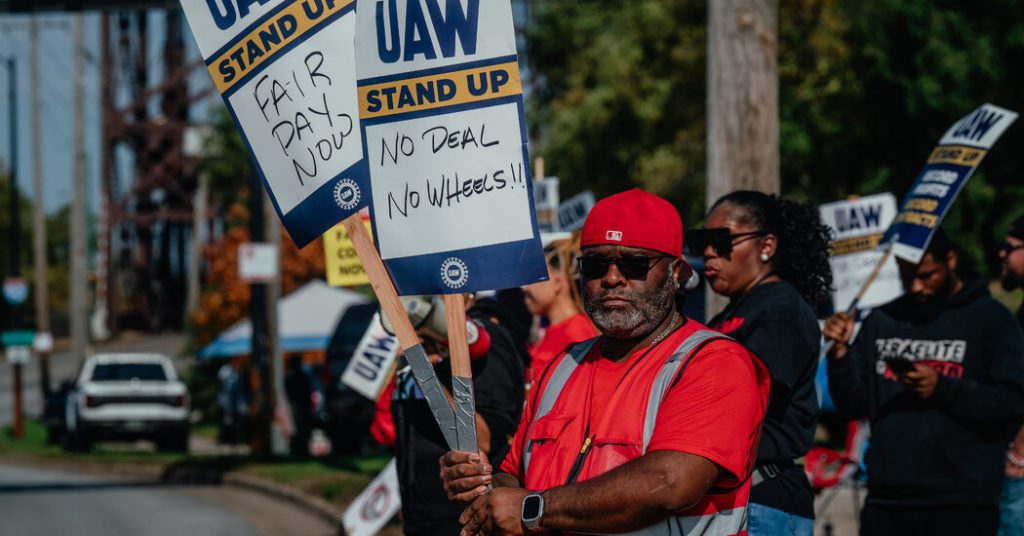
[69,13,89,360]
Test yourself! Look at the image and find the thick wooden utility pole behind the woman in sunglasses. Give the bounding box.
[707,0,779,318]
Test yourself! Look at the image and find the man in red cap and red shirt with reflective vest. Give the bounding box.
[440,190,769,535]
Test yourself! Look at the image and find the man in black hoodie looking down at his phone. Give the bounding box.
[822,230,1024,535]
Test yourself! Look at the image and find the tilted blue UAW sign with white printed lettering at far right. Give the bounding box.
[883,104,1017,263]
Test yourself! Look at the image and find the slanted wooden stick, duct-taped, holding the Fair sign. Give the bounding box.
[342,213,458,452]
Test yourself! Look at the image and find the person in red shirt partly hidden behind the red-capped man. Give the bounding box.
[522,233,598,383]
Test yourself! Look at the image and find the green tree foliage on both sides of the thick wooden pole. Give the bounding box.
[529,0,1024,274]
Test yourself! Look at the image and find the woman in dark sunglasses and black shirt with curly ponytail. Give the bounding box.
[686,192,831,535]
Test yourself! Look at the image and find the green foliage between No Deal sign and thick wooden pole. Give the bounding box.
[529,0,707,221]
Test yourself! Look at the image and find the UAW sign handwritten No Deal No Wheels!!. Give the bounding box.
[355,0,547,295]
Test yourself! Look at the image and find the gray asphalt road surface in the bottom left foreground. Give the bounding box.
[0,464,337,536]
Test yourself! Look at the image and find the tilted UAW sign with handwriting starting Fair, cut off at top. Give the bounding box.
[181,0,369,247]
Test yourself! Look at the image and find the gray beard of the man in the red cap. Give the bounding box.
[583,277,676,339]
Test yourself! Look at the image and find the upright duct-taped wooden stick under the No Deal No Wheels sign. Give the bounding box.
[444,294,478,452]
